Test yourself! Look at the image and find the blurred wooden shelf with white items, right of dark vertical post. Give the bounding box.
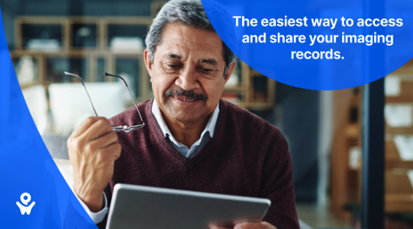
[385,60,413,216]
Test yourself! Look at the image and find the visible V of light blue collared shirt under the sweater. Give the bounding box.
[152,99,219,158]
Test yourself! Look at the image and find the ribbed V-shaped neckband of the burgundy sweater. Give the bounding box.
[145,99,225,171]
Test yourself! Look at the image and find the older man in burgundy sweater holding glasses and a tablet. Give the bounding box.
[68,0,299,229]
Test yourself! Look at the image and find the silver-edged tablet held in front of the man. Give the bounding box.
[107,184,271,229]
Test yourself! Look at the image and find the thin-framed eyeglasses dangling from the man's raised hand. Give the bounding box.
[65,72,145,133]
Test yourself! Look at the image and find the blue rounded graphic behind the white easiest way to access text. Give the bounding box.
[202,0,413,90]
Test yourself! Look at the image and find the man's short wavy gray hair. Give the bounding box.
[145,0,236,75]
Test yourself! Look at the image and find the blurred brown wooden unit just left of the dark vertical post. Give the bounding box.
[330,87,361,220]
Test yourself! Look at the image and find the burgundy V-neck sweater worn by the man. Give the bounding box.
[99,100,299,229]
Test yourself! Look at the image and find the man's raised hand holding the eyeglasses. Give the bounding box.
[67,117,121,212]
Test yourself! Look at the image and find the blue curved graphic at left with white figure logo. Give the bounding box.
[0,5,97,229]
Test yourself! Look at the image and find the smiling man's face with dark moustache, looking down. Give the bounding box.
[145,23,235,124]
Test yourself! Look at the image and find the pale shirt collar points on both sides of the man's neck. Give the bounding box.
[152,99,219,143]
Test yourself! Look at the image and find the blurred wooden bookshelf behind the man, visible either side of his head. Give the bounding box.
[11,14,275,110]
